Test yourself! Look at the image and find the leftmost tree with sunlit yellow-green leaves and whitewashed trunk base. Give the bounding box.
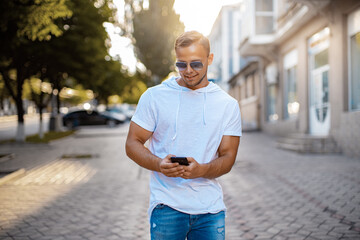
[0,0,72,141]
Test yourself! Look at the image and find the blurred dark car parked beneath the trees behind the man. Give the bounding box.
[63,110,126,129]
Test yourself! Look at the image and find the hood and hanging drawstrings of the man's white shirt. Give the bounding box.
[162,77,221,141]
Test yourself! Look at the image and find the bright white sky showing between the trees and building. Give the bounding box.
[105,0,241,71]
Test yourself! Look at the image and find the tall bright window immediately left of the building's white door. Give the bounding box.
[284,50,300,119]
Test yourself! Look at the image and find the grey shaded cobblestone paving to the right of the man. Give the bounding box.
[222,134,360,240]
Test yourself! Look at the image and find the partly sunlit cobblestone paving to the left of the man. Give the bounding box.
[0,125,149,240]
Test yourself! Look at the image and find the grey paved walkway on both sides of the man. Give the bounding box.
[0,124,360,240]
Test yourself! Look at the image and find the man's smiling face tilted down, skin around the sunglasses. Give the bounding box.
[176,43,213,90]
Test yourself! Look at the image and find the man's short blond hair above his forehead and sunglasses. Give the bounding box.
[175,31,210,56]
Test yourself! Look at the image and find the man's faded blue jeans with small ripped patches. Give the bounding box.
[150,204,225,240]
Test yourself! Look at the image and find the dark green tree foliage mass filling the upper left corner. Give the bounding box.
[0,0,126,139]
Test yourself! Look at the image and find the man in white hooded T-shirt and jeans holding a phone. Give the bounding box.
[126,31,241,240]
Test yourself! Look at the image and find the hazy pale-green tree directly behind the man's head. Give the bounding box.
[125,0,184,84]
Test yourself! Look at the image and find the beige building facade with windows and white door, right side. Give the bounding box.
[225,0,360,157]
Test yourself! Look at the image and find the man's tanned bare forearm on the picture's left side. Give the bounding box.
[125,140,161,172]
